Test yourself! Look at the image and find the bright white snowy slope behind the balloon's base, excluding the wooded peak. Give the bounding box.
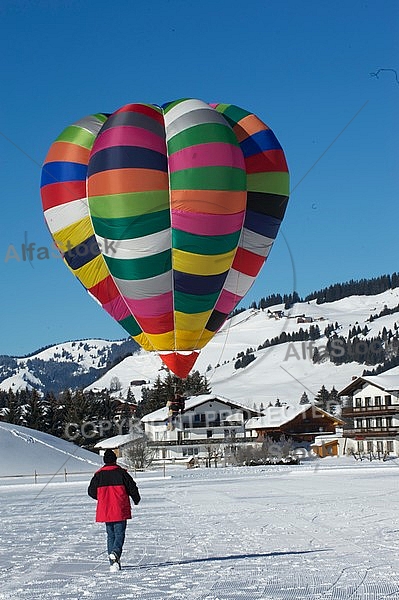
[87,288,399,407]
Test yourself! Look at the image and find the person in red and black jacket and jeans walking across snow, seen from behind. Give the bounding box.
[87,450,140,571]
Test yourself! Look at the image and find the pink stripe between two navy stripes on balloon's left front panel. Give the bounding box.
[92,125,166,155]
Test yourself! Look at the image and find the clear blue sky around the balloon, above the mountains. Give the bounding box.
[0,0,399,355]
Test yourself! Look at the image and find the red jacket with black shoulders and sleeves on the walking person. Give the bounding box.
[87,465,140,523]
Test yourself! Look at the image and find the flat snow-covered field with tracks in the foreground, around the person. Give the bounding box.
[0,458,399,600]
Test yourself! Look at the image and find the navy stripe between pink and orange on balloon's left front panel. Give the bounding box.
[88,146,168,177]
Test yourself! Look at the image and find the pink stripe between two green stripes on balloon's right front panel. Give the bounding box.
[169,142,245,173]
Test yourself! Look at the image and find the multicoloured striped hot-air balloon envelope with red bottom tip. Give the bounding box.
[41,99,289,378]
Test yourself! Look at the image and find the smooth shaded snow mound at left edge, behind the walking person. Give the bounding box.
[0,422,101,477]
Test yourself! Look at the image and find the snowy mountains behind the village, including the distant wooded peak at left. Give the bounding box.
[0,288,399,406]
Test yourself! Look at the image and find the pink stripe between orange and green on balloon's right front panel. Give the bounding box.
[172,210,245,235]
